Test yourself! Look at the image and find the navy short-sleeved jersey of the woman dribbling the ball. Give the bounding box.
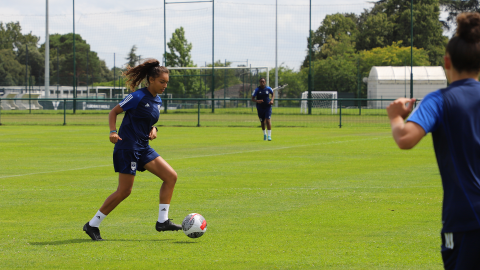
[115,88,162,150]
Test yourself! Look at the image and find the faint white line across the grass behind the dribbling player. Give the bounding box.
[0,136,391,179]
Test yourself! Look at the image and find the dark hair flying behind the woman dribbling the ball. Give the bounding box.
[122,58,170,92]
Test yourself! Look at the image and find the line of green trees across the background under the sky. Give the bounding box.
[0,0,472,98]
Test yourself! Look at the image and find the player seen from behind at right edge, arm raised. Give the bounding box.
[387,13,480,269]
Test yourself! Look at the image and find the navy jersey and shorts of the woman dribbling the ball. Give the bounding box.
[113,88,162,175]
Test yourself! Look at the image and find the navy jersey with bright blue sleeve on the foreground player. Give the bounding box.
[407,79,480,232]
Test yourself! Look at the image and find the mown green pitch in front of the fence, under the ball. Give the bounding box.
[0,125,443,269]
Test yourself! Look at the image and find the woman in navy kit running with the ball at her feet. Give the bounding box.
[83,59,181,240]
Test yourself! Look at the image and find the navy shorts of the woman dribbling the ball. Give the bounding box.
[113,146,160,175]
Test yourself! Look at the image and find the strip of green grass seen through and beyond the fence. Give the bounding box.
[0,107,390,128]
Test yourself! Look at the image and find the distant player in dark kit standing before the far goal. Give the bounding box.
[252,78,275,141]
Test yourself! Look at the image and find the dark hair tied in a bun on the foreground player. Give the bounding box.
[446,12,480,72]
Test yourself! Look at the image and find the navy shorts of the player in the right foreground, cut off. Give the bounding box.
[442,230,480,270]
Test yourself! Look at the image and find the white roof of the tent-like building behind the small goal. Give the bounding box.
[368,66,447,81]
